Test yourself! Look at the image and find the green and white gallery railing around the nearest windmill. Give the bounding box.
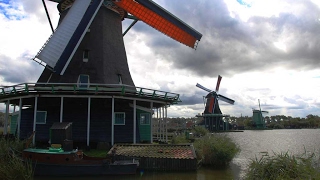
[0,83,181,104]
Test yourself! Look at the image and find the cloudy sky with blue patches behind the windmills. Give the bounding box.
[0,0,320,118]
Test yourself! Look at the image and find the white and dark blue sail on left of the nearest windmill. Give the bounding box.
[35,0,103,75]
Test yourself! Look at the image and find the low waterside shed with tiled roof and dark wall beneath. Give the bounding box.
[108,144,198,171]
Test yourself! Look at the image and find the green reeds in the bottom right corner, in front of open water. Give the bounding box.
[245,152,320,180]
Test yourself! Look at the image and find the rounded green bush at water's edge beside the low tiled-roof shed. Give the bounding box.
[194,134,240,167]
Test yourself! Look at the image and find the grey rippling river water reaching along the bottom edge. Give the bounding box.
[35,129,320,180]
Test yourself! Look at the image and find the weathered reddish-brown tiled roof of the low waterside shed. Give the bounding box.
[108,144,197,159]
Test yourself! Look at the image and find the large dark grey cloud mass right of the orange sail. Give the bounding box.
[129,0,320,77]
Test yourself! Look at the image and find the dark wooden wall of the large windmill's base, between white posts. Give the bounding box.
[21,97,140,143]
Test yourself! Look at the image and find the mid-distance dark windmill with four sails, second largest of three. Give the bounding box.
[196,75,234,131]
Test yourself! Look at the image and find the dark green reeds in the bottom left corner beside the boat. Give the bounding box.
[0,138,33,180]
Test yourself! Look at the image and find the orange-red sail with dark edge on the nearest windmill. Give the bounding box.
[115,0,202,49]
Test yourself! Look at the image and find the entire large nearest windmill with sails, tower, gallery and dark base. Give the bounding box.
[0,0,202,146]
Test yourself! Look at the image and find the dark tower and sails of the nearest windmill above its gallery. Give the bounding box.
[33,0,202,86]
